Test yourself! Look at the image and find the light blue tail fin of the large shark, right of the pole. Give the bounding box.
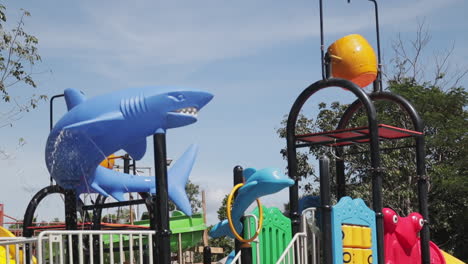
[167,144,198,216]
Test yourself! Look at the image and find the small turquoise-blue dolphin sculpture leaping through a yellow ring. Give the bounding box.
[210,168,294,238]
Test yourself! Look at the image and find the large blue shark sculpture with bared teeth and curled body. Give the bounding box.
[45,87,213,215]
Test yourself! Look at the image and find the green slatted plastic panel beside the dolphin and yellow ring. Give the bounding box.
[244,206,292,264]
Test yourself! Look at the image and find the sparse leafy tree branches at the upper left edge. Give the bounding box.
[0,4,47,156]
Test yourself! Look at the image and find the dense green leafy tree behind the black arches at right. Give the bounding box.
[277,26,468,261]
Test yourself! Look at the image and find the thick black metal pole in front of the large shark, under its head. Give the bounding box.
[153,133,171,264]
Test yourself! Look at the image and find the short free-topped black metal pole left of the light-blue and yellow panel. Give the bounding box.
[319,156,333,264]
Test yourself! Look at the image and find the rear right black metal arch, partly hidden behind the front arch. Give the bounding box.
[336,91,430,263]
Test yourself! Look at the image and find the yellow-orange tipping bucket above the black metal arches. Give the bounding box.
[328,34,377,88]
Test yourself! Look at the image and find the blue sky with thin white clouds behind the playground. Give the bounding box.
[0,0,468,227]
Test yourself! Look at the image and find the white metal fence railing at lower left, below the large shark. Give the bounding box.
[0,230,155,264]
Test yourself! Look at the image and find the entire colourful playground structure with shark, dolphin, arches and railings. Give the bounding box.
[0,0,462,264]
